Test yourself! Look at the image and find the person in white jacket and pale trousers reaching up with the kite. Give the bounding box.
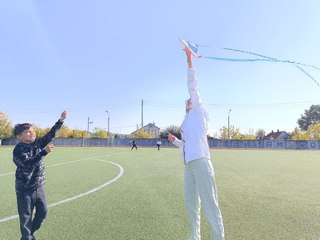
[168,48,224,240]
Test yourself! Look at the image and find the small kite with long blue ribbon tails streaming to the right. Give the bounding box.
[179,38,320,87]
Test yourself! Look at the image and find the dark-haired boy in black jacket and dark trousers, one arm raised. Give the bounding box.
[13,111,67,240]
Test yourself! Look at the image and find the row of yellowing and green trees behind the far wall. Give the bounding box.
[0,105,320,140]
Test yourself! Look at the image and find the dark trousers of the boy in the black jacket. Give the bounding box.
[16,186,48,240]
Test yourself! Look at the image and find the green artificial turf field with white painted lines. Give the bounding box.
[0,146,320,240]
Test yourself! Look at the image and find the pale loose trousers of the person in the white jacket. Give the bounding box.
[184,158,224,240]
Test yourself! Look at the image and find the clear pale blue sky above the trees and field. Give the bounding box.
[0,0,320,135]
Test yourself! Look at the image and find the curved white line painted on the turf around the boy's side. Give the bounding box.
[0,157,124,223]
